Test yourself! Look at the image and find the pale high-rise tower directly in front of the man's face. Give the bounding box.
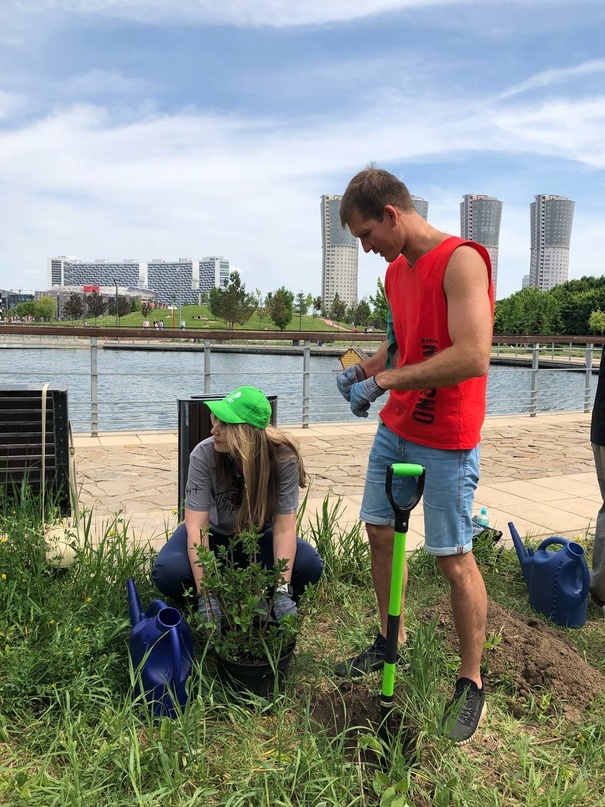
[321,194,359,309]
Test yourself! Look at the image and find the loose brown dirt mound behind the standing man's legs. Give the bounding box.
[426,596,605,723]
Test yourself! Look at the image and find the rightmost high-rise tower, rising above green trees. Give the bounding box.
[529,194,575,291]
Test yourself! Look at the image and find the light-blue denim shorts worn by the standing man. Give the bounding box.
[360,423,479,556]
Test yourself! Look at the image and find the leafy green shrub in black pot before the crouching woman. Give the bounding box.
[197,532,300,695]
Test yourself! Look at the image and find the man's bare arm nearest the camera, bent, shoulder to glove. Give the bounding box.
[372,246,492,389]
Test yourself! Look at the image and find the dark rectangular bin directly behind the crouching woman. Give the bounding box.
[177,390,277,521]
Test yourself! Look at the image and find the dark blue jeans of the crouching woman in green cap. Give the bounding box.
[152,524,324,600]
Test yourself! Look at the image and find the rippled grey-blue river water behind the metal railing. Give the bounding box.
[0,348,596,431]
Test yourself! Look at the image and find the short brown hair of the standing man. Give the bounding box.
[340,167,416,227]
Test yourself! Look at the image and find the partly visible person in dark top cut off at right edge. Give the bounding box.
[590,356,605,613]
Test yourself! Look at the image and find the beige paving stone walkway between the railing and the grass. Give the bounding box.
[75,412,601,549]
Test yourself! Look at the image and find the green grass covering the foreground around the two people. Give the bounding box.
[0,492,605,807]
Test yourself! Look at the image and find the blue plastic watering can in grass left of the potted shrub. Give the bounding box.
[126,578,193,717]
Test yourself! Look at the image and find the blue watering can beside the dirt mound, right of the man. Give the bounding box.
[508,521,590,628]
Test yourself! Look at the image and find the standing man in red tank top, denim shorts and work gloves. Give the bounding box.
[336,168,493,743]
